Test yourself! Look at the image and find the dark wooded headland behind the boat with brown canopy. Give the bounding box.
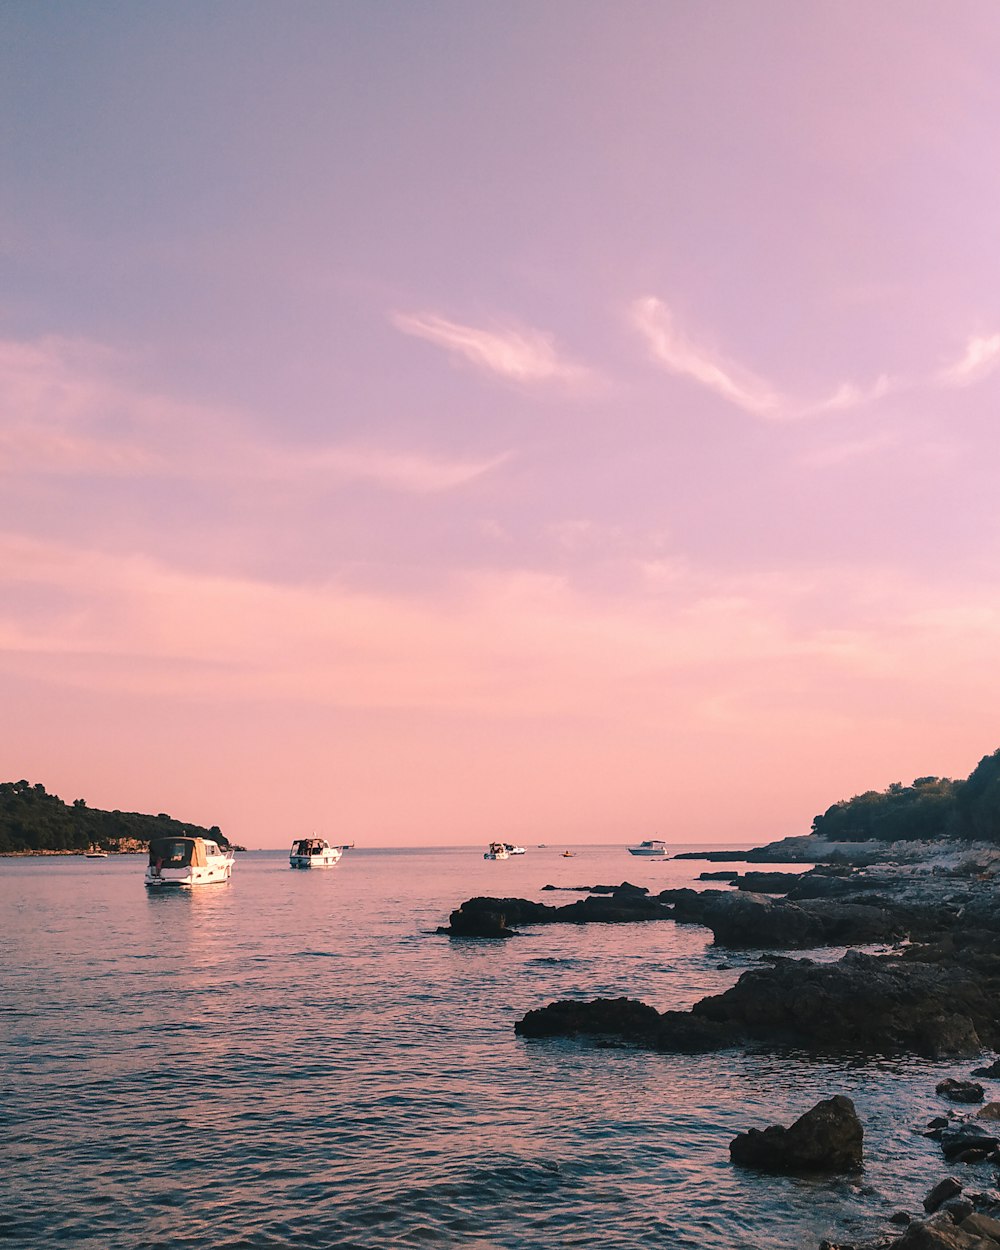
[0,780,236,855]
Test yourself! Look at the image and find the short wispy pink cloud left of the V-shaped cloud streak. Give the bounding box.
[390,313,591,384]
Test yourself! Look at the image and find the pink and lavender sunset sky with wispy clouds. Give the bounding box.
[0,0,1000,846]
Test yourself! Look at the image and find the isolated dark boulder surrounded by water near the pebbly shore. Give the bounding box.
[729,1094,864,1174]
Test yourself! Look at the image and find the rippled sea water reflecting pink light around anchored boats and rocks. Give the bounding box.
[0,846,986,1250]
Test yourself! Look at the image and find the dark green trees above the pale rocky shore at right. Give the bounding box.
[813,750,1000,843]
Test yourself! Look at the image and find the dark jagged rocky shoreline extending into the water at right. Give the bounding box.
[439,836,1000,1250]
